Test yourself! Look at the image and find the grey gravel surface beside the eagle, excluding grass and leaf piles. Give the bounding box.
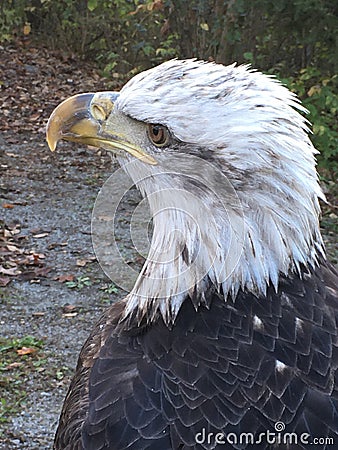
[0,137,140,450]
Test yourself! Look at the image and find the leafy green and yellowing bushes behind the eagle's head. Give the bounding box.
[0,0,338,172]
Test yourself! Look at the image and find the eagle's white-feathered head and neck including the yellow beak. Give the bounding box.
[47,60,323,323]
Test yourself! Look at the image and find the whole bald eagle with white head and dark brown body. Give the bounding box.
[47,60,338,450]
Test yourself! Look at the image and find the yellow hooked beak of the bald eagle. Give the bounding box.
[46,92,157,165]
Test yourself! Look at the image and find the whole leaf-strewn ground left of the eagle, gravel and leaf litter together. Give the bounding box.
[0,43,133,450]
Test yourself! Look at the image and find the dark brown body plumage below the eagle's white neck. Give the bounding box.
[54,262,338,450]
